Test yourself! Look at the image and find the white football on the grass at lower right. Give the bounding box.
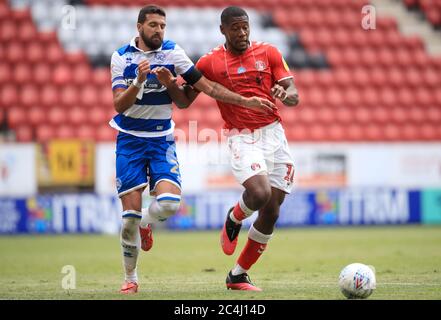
[338,263,377,299]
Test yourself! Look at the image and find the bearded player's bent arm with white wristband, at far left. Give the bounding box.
[113,60,150,113]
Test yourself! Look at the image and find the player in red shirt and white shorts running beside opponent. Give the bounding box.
[155,7,299,291]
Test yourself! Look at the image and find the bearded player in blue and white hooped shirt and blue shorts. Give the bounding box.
[110,6,274,294]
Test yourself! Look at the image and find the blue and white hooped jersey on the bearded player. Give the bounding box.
[109,37,194,138]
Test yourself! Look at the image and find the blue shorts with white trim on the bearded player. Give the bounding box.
[116,132,181,197]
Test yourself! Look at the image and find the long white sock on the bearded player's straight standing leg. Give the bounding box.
[120,210,141,282]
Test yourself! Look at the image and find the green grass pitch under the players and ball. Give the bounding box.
[0,226,441,300]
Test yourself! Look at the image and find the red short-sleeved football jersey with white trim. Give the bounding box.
[196,41,292,130]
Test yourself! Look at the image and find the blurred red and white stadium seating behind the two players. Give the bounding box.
[0,0,441,142]
